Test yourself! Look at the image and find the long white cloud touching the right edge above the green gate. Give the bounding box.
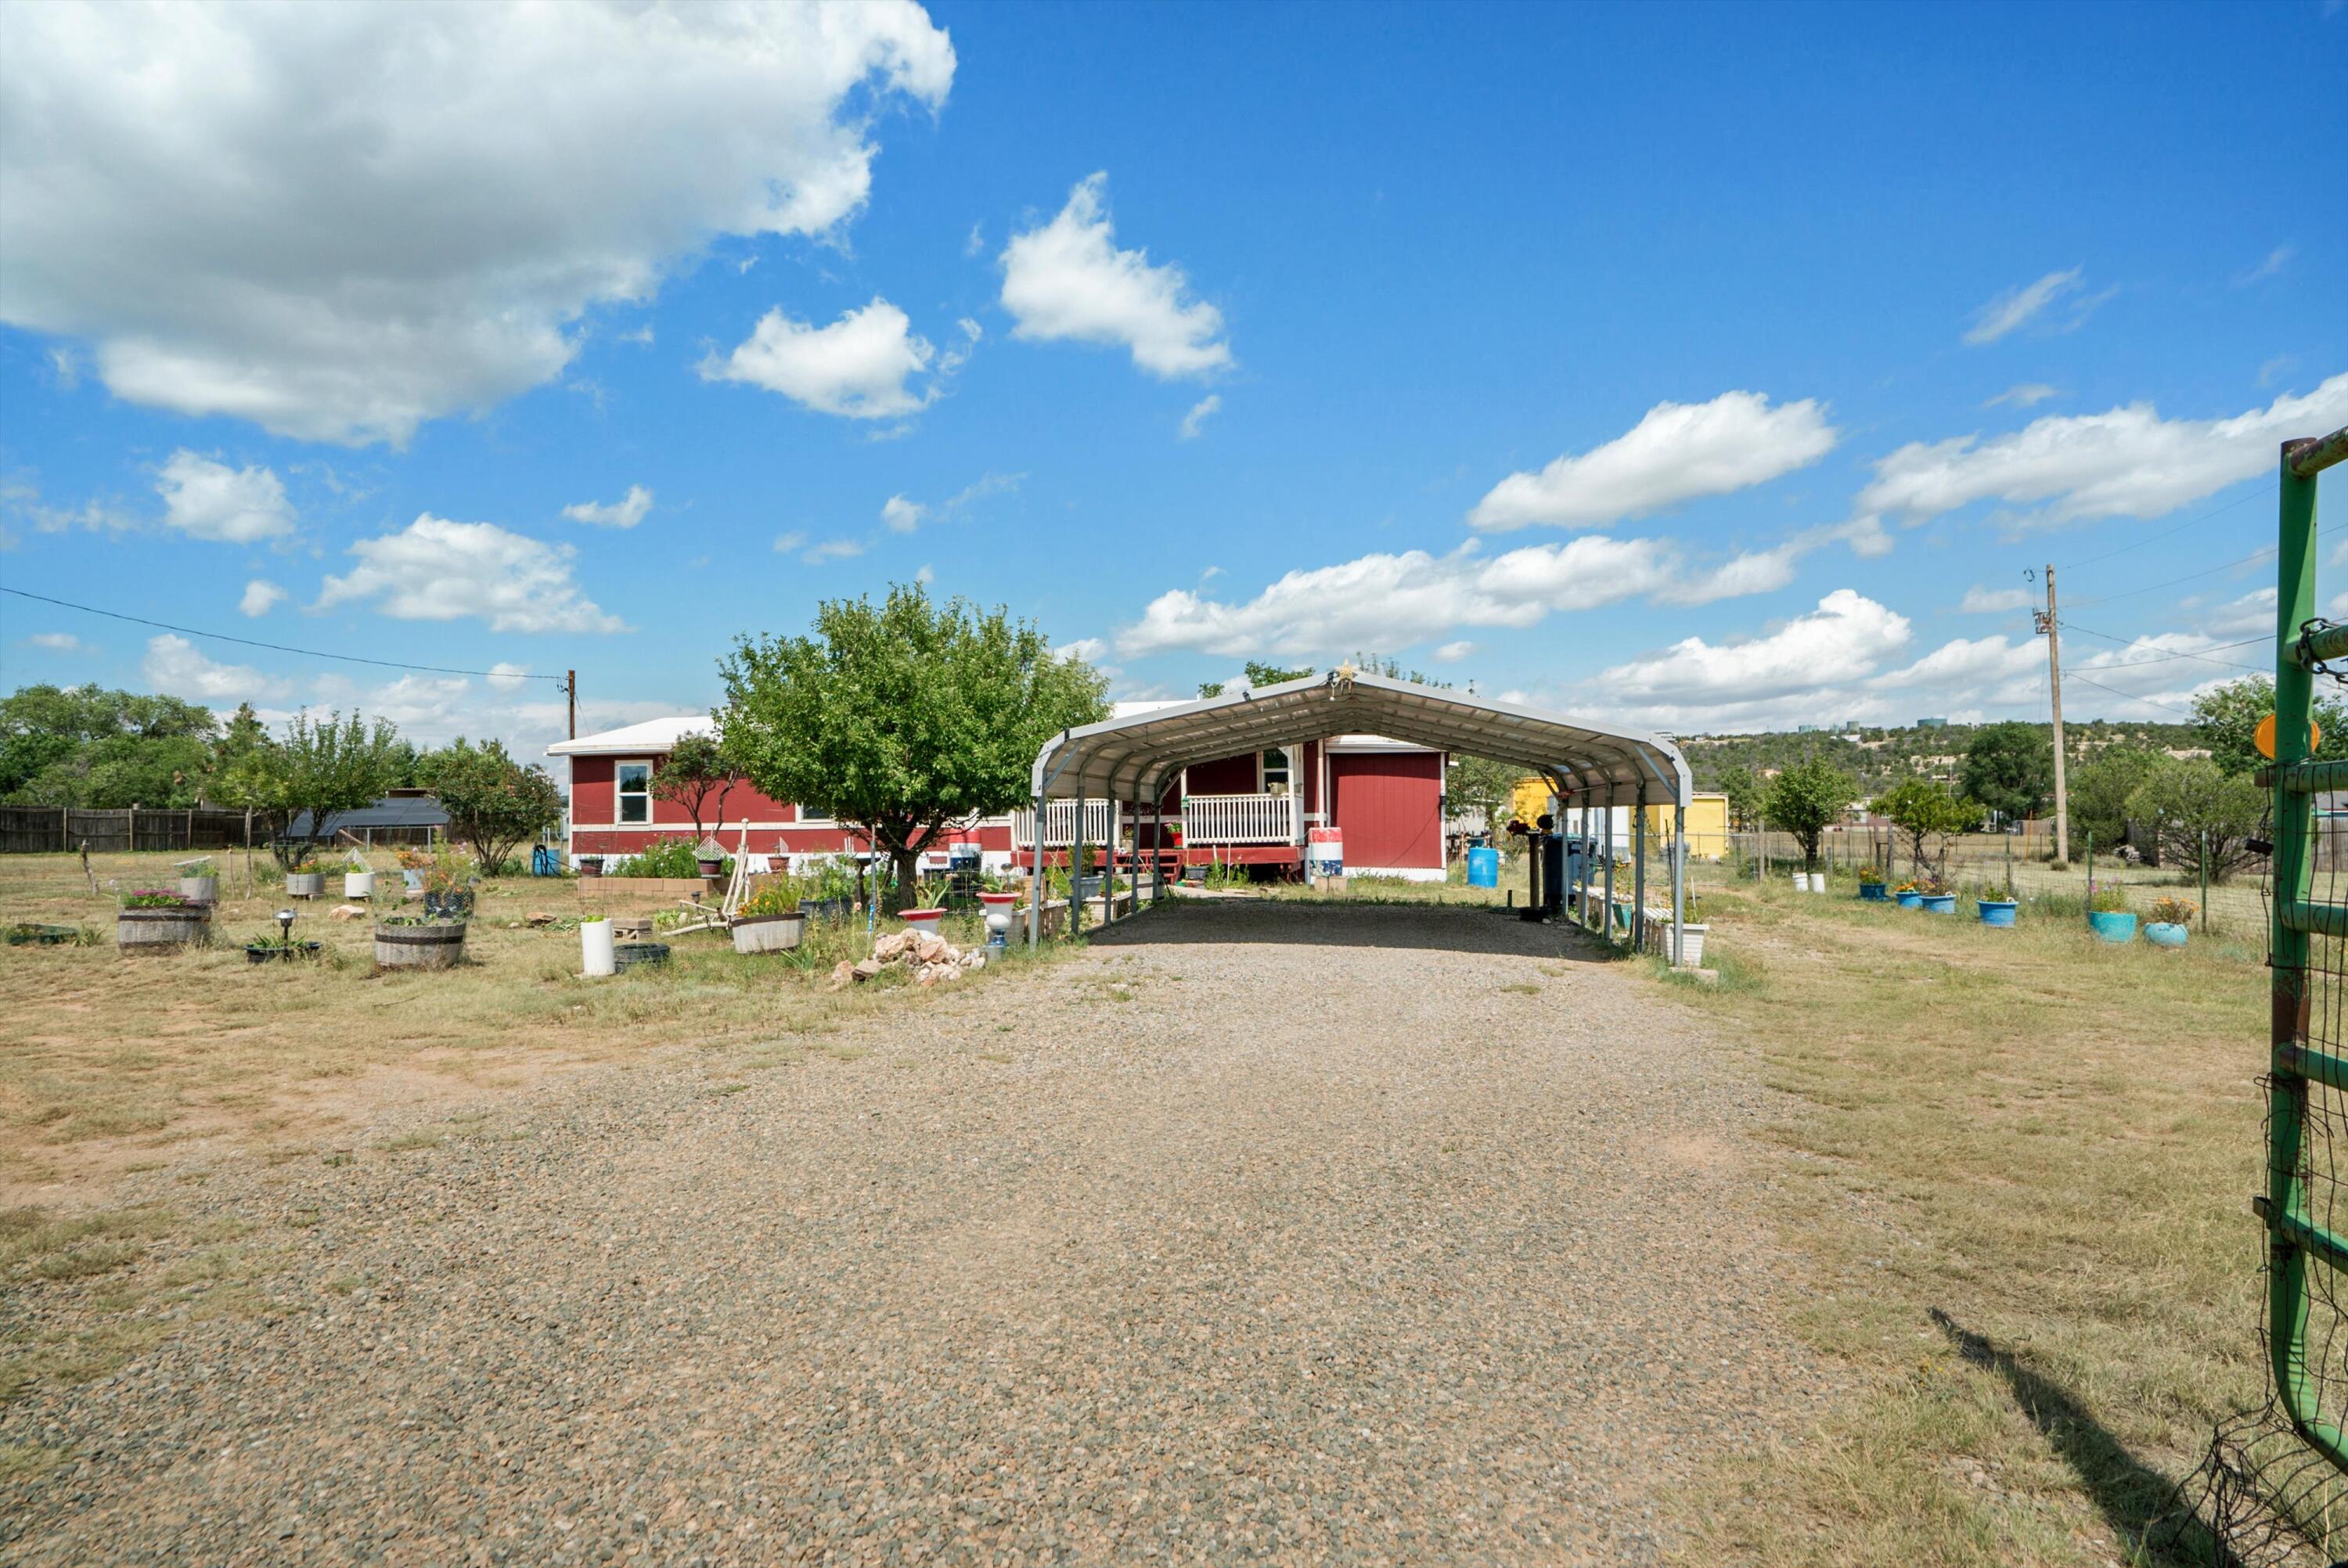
[1857,373,2348,523]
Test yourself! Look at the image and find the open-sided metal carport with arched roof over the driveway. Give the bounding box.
[1028,669,1691,962]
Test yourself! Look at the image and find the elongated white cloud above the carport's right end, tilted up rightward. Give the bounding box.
[1468,392,1836,530]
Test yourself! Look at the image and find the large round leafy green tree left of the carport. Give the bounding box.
[716,584,1108,913]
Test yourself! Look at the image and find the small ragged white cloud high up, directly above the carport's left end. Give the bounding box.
[1003,174,1230,380]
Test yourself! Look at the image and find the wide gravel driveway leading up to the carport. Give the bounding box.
[0,901,1810,1563]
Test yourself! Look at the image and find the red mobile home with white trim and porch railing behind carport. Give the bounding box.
[547,702,1446,880]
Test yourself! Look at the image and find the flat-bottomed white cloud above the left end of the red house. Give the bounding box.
[317,512,627,631]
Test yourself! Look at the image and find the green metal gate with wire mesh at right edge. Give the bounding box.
[2259,430,2348,1472]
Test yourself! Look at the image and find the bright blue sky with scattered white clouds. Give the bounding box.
[0,0,2348,746]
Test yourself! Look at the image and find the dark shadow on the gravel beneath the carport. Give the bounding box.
[1089,899,1620,965]
